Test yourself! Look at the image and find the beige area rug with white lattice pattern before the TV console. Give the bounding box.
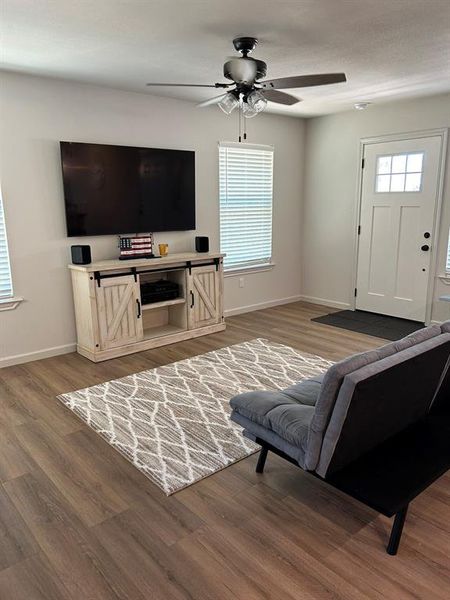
[58,339,332,495]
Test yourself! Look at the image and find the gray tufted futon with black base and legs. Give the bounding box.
[230,321,450,554]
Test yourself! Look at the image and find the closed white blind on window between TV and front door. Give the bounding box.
[219,142,273,270]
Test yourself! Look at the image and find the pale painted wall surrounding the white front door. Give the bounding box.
[301,94,450,320]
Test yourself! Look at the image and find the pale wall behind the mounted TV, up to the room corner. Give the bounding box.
[0,74,304,365]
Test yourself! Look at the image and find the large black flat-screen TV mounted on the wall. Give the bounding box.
[60,142,195,237]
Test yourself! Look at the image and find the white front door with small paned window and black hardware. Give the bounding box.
[356,136,441,322]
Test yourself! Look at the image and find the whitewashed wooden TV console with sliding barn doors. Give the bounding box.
[69,253,225,362]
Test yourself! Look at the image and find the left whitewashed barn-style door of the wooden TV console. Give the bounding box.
[96,275,144,350]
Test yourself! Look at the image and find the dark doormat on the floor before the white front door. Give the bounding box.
[311,310,424,342]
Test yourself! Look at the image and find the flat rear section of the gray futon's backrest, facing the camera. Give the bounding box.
[316,333,450,477]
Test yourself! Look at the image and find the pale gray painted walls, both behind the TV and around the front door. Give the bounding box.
[0,69,450,366]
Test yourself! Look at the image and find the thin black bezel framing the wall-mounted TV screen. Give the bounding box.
[59,140,197,238]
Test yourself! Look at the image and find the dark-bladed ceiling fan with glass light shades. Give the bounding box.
[147,37,347,118]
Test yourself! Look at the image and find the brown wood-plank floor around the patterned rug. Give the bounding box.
[0,303,450,600]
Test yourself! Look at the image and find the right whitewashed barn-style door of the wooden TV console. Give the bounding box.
[188,265,222,329]
